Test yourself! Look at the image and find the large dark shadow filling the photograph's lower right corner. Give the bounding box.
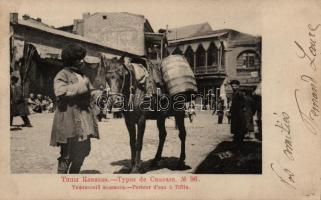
[194,141,262,174]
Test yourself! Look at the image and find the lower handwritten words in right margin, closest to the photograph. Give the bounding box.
[270,112,296,189]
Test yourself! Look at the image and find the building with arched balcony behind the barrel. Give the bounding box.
[167,23,261,104]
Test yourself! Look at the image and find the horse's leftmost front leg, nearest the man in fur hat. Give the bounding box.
[125,115,136,169]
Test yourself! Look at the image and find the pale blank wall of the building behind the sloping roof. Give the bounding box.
[83,13,146,55]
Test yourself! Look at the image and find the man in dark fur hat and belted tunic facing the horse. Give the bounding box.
[50,44,99,174]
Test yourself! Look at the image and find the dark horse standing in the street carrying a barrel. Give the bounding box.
[105,59,186,173]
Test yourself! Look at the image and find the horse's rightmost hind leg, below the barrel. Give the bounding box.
[175,112,186,168]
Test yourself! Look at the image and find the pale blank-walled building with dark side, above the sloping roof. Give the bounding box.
[58,12,166,61]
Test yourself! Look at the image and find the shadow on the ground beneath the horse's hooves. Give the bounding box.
[111,157,191,174]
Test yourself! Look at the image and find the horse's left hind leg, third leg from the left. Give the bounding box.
[152,117,167,166]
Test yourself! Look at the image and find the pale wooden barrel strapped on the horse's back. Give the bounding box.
[161,55,197,96]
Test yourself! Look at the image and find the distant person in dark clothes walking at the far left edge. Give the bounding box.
[10,76,32,127]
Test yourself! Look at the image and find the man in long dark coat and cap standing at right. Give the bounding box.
[230,80,247,143]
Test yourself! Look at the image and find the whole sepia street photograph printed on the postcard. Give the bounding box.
[10,7,262,174]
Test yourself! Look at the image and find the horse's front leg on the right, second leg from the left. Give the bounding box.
[132,114,146,173]
